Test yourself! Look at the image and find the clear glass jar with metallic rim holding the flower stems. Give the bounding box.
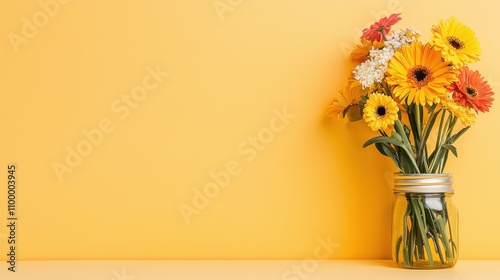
[392,173,458,269]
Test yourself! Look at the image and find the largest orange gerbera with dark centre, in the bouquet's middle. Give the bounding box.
[387,41,458,105]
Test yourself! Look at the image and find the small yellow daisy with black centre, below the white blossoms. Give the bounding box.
[363,93,399,131]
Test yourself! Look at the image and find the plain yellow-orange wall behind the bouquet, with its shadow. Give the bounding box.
[0,0,500,260]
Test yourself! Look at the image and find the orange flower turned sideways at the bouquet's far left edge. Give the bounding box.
[328,79,369,122]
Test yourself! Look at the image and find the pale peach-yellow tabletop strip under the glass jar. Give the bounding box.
[0,260,500,280]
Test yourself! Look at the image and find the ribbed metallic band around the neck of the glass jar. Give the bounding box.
[394,173,454,193]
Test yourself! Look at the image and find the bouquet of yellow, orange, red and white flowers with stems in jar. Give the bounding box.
[328,14,493,268]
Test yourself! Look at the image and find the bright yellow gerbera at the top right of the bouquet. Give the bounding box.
[431,17,481,68]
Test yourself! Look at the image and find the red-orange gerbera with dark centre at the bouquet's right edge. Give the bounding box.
[448,66,494,113]
